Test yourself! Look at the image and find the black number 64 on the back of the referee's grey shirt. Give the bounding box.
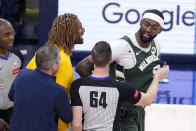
[90,91,107,108]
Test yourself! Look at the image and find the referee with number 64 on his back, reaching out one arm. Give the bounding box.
[71,41,169,131]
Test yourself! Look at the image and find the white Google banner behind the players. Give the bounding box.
[58,0,196,54]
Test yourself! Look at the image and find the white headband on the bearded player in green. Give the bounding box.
[142,13,164,27]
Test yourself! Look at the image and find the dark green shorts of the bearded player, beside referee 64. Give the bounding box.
[120,102,145,131]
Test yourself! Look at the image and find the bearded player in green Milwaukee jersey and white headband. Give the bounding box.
[76,10,167,131]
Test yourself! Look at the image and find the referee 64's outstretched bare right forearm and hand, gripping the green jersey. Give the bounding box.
[135,65,169,106]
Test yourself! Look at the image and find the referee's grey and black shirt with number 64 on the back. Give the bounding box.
[71,76,141,131]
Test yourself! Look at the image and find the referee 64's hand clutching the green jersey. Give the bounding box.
[154,65,169,80]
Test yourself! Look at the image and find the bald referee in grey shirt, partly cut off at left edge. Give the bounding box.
[0,18,24,127]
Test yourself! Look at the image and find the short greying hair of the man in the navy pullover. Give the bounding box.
[35,45,60,70]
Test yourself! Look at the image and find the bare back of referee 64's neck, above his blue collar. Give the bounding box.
[92,67,109,77]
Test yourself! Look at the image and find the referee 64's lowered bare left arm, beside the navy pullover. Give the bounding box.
[71,106,82,131]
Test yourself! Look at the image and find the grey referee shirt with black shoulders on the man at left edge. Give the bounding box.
[0,48,24,110]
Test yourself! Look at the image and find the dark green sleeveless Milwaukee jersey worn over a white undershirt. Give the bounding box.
[110,36,163,92]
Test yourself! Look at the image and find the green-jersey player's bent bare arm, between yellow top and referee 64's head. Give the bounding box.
[76,56,94,77]
